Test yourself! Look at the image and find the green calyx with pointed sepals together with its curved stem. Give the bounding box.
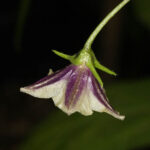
[53,0,130,87]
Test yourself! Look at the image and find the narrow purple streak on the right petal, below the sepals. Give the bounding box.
[89,73,116,113]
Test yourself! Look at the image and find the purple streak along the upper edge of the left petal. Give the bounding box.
[28,65,76,89]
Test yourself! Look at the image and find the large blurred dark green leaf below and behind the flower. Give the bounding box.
[20,80,150,150]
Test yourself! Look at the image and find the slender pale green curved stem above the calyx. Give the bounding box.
[84,0,130,50]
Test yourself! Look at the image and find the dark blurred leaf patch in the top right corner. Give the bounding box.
[133,0,150,29]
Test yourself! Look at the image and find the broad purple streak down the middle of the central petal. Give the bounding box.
[65,67,88,109]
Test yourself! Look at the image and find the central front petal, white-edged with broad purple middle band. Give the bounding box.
[53,66,92,116]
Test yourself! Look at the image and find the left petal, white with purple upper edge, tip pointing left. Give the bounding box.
[20,65,75,98]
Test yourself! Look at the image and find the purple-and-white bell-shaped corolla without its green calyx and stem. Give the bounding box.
[20,64,124,120]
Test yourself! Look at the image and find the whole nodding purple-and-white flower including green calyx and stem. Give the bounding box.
[20,0,130,120]
